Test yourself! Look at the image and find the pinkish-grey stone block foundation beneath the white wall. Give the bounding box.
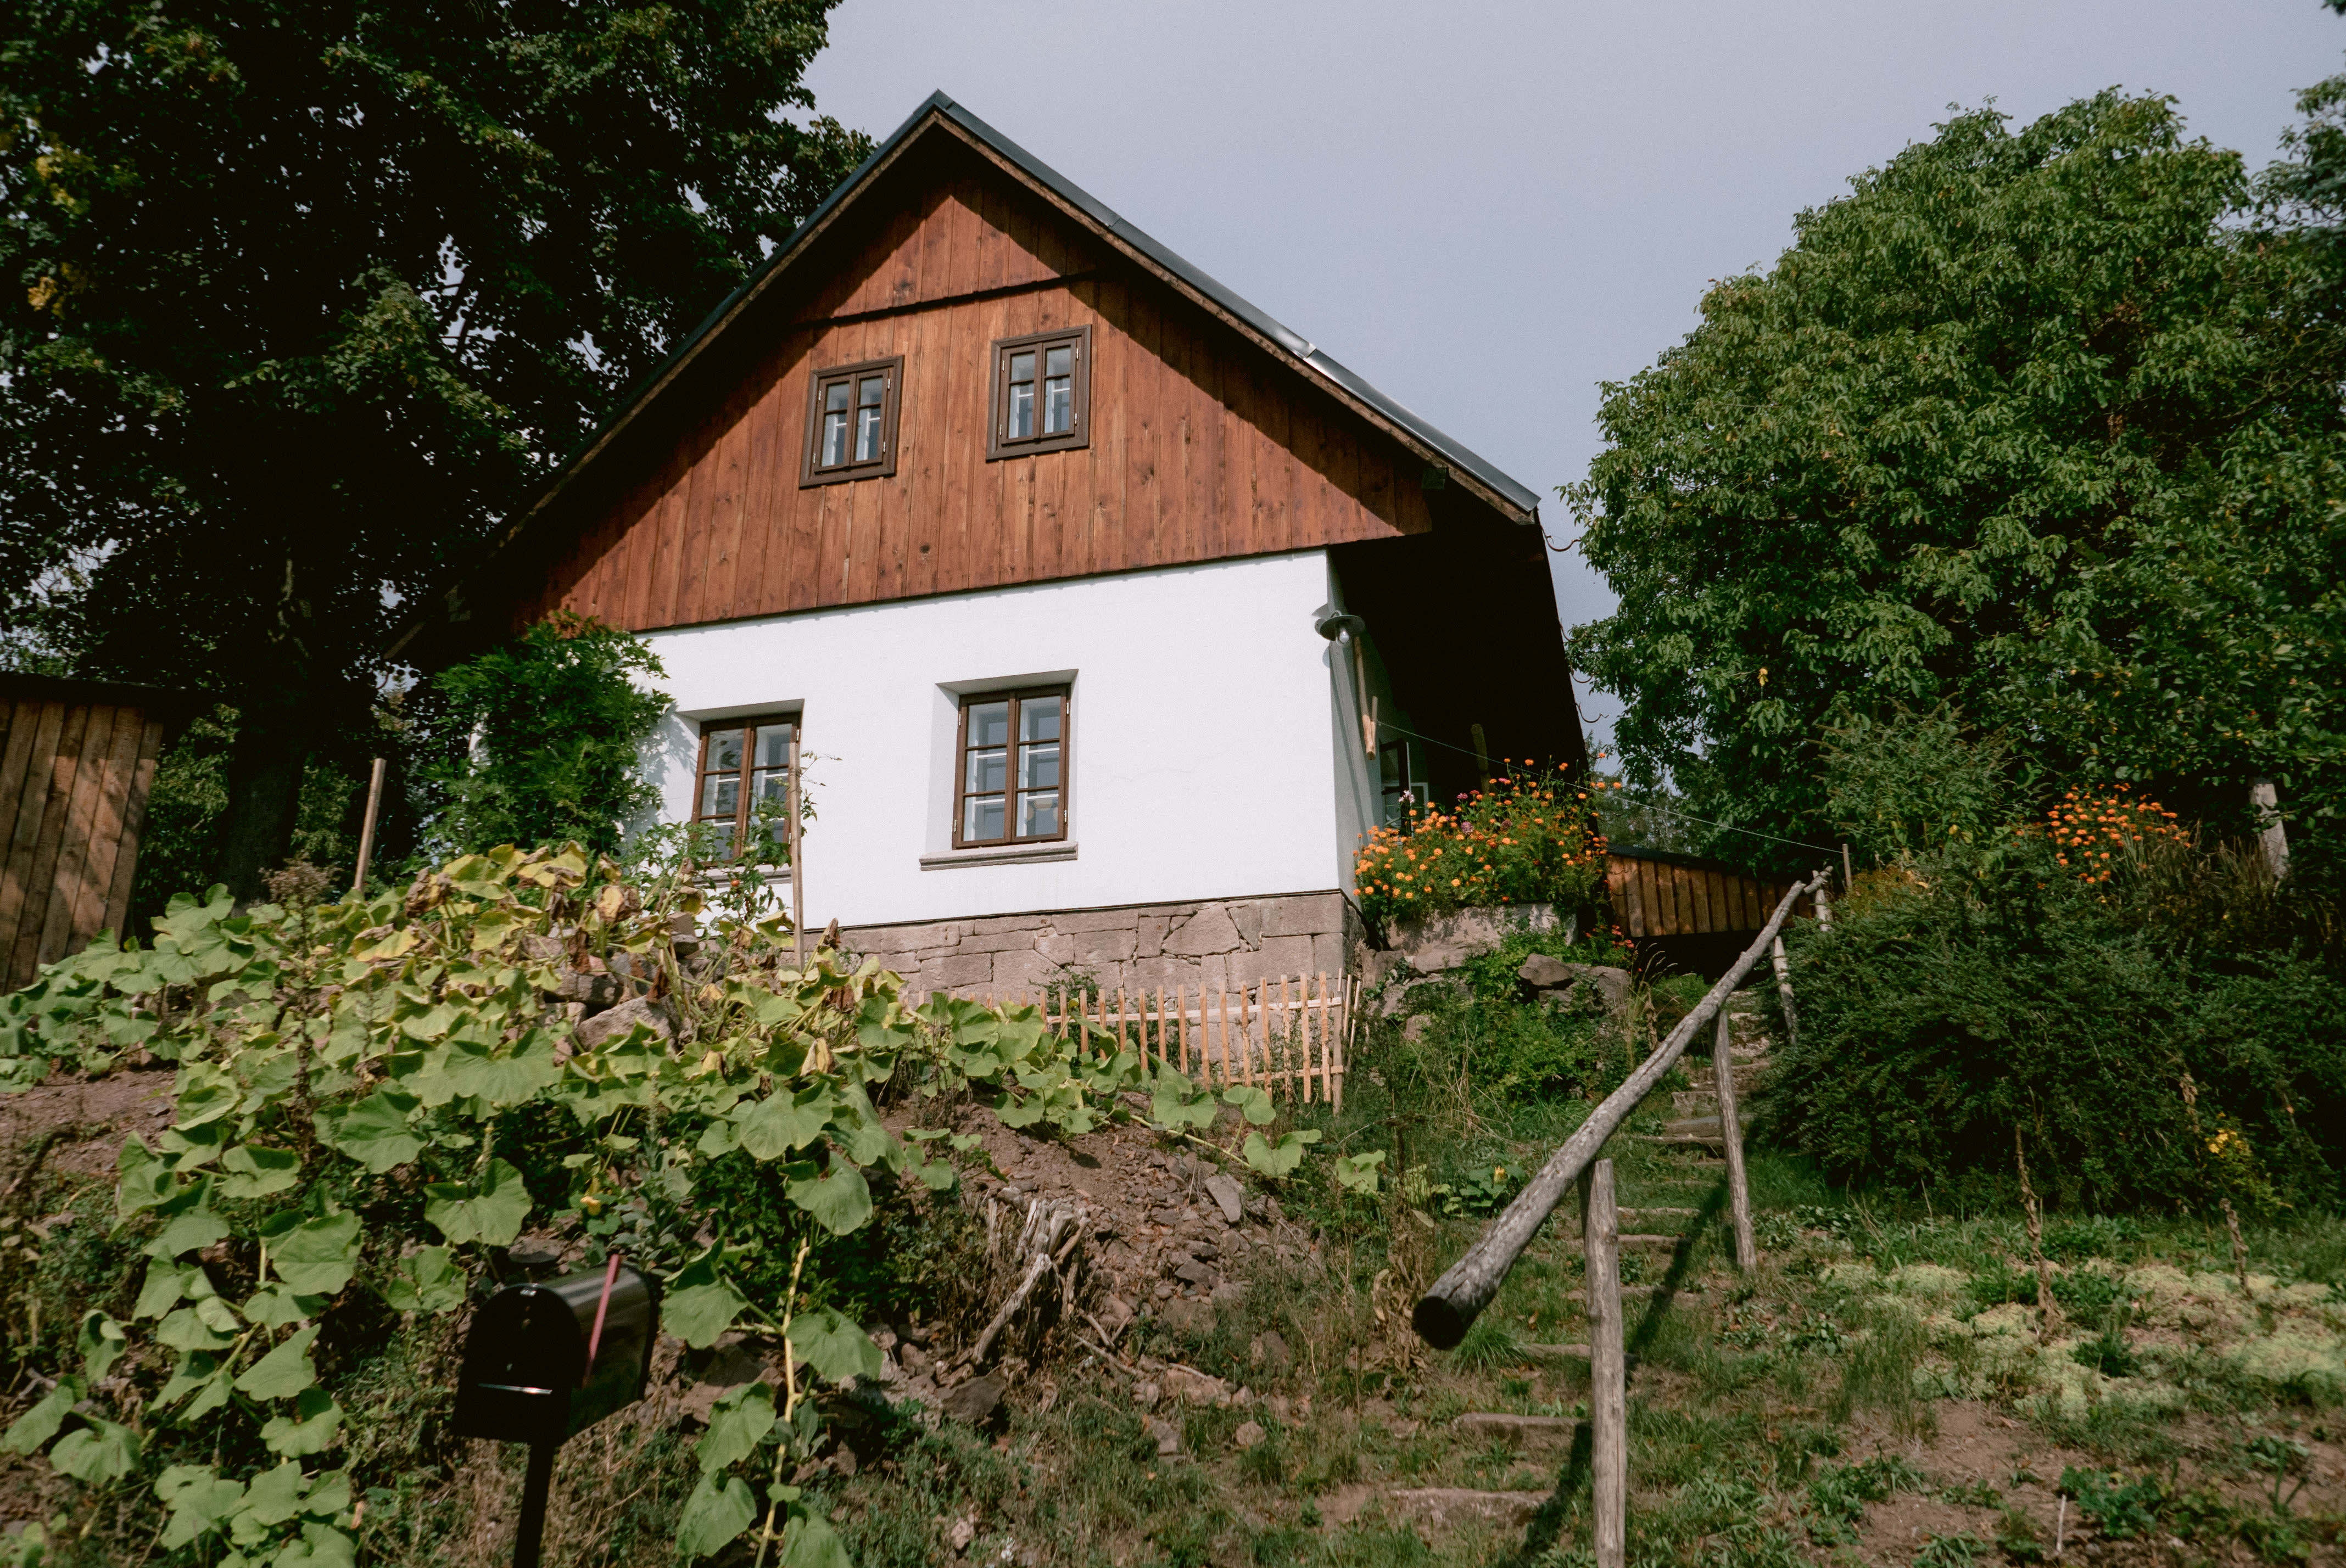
[840,893,1361,994]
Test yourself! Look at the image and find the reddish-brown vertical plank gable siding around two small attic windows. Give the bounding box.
[516,166,1431,630]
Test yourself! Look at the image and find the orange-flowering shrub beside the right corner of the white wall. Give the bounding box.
[1354,764,1605,926]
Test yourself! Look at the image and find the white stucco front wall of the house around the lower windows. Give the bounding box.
[647,551,1358,926]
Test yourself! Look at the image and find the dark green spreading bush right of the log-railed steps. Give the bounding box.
[1769,835,2346,1209]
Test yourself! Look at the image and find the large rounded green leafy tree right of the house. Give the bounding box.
[1565,91,2346,881]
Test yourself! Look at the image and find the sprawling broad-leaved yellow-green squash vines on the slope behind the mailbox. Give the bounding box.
[0,846,1316,1566]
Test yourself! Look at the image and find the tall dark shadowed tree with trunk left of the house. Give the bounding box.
[0,0,868,895]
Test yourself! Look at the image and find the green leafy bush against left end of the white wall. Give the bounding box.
[432,612,669,853]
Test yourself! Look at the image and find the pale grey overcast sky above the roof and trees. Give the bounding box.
[809,0,2346,745]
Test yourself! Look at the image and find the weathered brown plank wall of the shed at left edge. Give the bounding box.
[0,698,164,992]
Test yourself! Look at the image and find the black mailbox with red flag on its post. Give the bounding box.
[453,1252,659,1568]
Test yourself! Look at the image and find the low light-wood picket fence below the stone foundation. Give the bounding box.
[915,970,1361,1111]
